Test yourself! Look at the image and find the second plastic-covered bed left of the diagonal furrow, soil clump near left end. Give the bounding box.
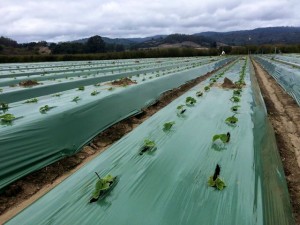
[0,57,217,103]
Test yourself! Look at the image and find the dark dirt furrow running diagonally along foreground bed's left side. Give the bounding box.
[0,58,236,224]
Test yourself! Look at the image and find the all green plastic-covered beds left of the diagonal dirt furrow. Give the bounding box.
[0,57,233,188]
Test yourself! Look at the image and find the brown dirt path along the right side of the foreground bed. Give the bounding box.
[252,60,300,224]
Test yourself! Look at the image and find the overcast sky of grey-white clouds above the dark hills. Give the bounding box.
[0,0,300,42]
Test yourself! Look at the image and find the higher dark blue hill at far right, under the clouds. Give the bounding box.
[194,27,300,45]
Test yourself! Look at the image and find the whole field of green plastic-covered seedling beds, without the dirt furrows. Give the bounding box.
[0,55,300,225]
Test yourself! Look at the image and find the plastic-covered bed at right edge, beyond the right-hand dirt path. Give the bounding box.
[255,57,300,106]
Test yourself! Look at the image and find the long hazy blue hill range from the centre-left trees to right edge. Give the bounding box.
[73,27,300,49]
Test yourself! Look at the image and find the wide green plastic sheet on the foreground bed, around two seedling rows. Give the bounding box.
[7,57,294,225]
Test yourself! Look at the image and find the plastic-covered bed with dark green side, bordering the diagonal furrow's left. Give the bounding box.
[0,58,232,189]
